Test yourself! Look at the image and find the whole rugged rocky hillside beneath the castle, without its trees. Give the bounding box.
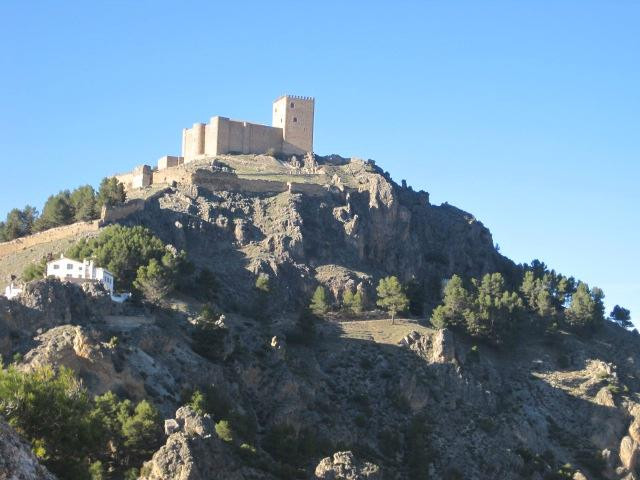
[0,156,640,480]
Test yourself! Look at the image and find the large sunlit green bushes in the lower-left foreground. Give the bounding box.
[0,367,162,480]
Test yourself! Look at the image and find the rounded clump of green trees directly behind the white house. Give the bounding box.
[67,225,167,289]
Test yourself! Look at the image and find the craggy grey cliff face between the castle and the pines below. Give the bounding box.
[111,160,513,314]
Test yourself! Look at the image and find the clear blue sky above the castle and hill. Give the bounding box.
[0,0,640,320]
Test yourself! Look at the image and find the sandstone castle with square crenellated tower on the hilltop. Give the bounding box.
[176,95,315,163]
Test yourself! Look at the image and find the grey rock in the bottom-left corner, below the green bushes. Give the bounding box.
[0,418,56,480]
